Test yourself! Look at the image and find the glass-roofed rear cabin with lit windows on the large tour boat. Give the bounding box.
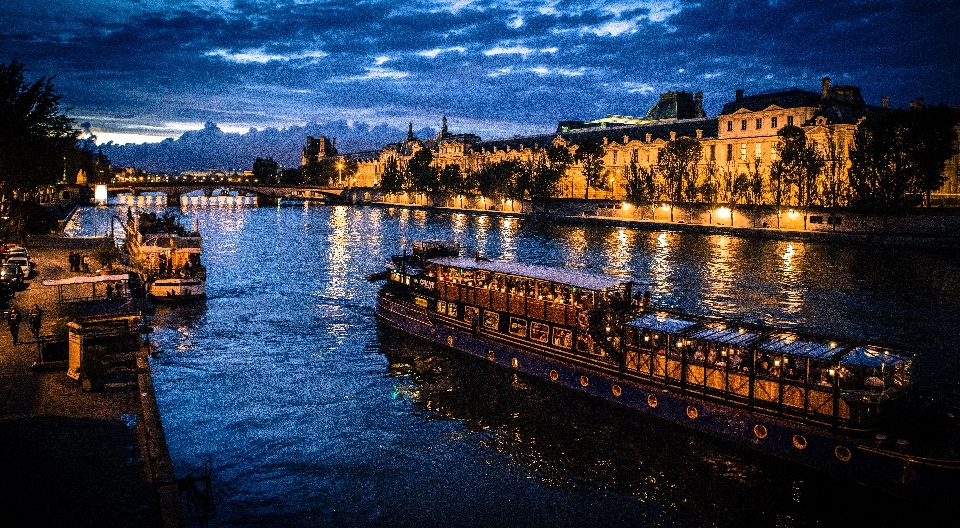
[624,313,912,430]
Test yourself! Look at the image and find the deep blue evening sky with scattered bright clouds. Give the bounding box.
[0,0,960,147]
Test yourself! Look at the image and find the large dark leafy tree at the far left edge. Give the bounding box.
[0,61,79,203]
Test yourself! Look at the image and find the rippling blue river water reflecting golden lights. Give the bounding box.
[137,207,960,527]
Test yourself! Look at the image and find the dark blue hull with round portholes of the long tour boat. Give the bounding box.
[375,290,960,491]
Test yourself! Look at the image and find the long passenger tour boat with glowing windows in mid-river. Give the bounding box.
[375,244,960,493]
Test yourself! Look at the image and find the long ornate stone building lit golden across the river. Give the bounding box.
[312,78,960,207]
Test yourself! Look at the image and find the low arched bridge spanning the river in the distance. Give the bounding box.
[107,182,374,204]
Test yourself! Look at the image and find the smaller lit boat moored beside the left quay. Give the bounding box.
[124,212,207,301]
